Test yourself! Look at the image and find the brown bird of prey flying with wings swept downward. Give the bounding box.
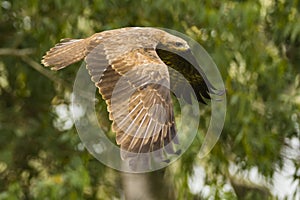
[41,27,215,161]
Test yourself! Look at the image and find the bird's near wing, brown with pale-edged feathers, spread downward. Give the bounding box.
[85,38,177,158]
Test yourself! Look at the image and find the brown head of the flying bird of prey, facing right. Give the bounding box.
[157,32,190,53]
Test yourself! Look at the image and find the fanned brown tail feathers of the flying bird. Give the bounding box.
[42,38,86,70]
